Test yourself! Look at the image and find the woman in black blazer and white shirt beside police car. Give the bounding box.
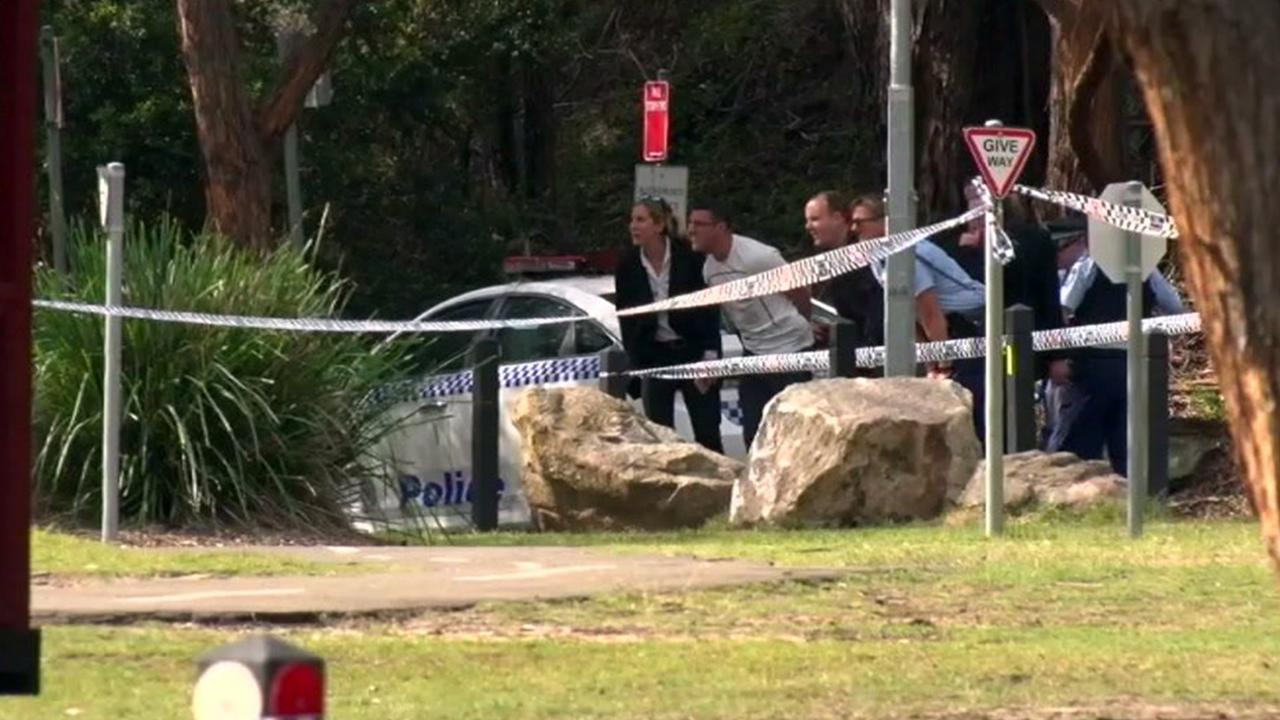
[613,199,724,452]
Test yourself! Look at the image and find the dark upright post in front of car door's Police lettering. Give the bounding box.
[471,338,502,532]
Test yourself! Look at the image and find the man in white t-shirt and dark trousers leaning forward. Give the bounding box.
[689,204,813,447]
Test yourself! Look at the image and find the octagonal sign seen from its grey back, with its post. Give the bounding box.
[1089,182,1169,538]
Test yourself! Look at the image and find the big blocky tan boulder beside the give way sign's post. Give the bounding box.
[730,378,980,525]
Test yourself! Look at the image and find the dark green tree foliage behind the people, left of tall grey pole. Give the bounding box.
[41,0,883,318]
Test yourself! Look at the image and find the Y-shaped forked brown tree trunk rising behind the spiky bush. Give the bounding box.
[177,0,360,250]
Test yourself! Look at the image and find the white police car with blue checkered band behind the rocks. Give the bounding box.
[353,256,746,529]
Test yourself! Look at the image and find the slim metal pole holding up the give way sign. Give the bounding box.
[974,120,1005,537]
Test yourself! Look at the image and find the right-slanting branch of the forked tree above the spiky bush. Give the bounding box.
[257,0,364,143]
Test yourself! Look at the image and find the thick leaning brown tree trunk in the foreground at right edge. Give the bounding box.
[1091,0,1280,571]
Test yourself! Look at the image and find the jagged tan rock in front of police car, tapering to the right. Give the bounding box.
[512,387,744,530]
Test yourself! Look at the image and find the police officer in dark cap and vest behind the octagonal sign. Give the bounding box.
[1047,214,1183,475]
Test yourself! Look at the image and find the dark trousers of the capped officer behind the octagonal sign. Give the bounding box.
[1048,352,1129,475]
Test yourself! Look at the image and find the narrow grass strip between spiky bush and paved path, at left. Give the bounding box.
[31,529,369,576]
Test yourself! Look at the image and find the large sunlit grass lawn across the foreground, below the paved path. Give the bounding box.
[0,518,1280,720]
